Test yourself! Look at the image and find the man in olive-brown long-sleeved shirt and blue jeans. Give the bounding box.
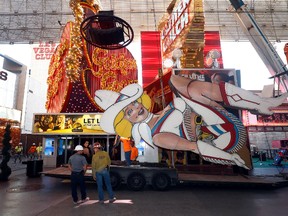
[92,142,116,203]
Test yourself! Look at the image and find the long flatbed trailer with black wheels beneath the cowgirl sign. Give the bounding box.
[41,165,288,191]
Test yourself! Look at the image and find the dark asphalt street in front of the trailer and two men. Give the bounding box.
[0,170,288,216]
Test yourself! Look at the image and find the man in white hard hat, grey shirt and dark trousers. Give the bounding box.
[68,145,89,204]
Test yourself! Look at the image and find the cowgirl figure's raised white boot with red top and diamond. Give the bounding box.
[219,83,288,115]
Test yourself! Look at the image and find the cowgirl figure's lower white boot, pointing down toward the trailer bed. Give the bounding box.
[197,140,249,170]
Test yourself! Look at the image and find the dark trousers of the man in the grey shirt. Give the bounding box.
[71,171,86,202]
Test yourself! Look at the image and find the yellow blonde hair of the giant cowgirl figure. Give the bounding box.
[113,93,151,138]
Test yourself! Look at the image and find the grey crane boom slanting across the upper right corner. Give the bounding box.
[230,0,288,92]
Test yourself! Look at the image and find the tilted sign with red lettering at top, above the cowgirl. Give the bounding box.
[162,0,192,53]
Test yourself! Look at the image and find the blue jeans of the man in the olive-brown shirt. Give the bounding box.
[96,168,114,201]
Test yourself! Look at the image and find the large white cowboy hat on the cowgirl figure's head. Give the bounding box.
[94,83,143,133]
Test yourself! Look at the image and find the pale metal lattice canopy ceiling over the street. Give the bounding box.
[0,0,288,44]
